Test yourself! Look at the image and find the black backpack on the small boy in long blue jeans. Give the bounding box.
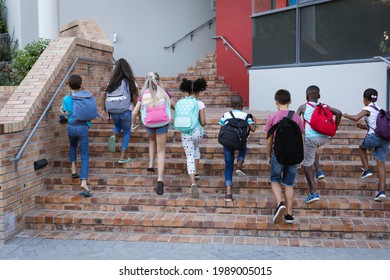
[218,111,249,150]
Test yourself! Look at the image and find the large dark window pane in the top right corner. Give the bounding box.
[300,0,390,63]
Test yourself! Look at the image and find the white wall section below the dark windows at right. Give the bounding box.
[249,62,387,114]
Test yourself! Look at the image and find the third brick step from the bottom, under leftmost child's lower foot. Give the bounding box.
[35,191,390,218]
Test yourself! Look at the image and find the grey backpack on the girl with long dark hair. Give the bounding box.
[105,80,131,114]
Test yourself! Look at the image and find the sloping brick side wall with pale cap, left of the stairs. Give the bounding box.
[0,21,113,242]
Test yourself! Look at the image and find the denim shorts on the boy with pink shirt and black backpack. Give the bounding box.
[271,154,298,187]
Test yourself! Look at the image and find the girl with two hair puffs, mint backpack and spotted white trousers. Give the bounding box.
[174,78,207,198]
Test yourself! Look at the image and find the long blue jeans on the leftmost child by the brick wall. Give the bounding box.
[67,124,89,180]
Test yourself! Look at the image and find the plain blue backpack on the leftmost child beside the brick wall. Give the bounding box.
[71,90,99,121]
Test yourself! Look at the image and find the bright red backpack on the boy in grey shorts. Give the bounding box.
[306,102,336,136]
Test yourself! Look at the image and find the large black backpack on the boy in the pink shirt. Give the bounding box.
[267,111,303,165]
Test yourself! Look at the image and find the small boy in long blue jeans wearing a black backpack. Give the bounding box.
[218,95,256,202]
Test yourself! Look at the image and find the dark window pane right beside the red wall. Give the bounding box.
[253,9,296,66]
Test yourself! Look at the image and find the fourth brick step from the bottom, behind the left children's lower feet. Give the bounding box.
[44,174,390,198]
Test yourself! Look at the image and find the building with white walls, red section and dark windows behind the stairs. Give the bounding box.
[6,0,390,112]
